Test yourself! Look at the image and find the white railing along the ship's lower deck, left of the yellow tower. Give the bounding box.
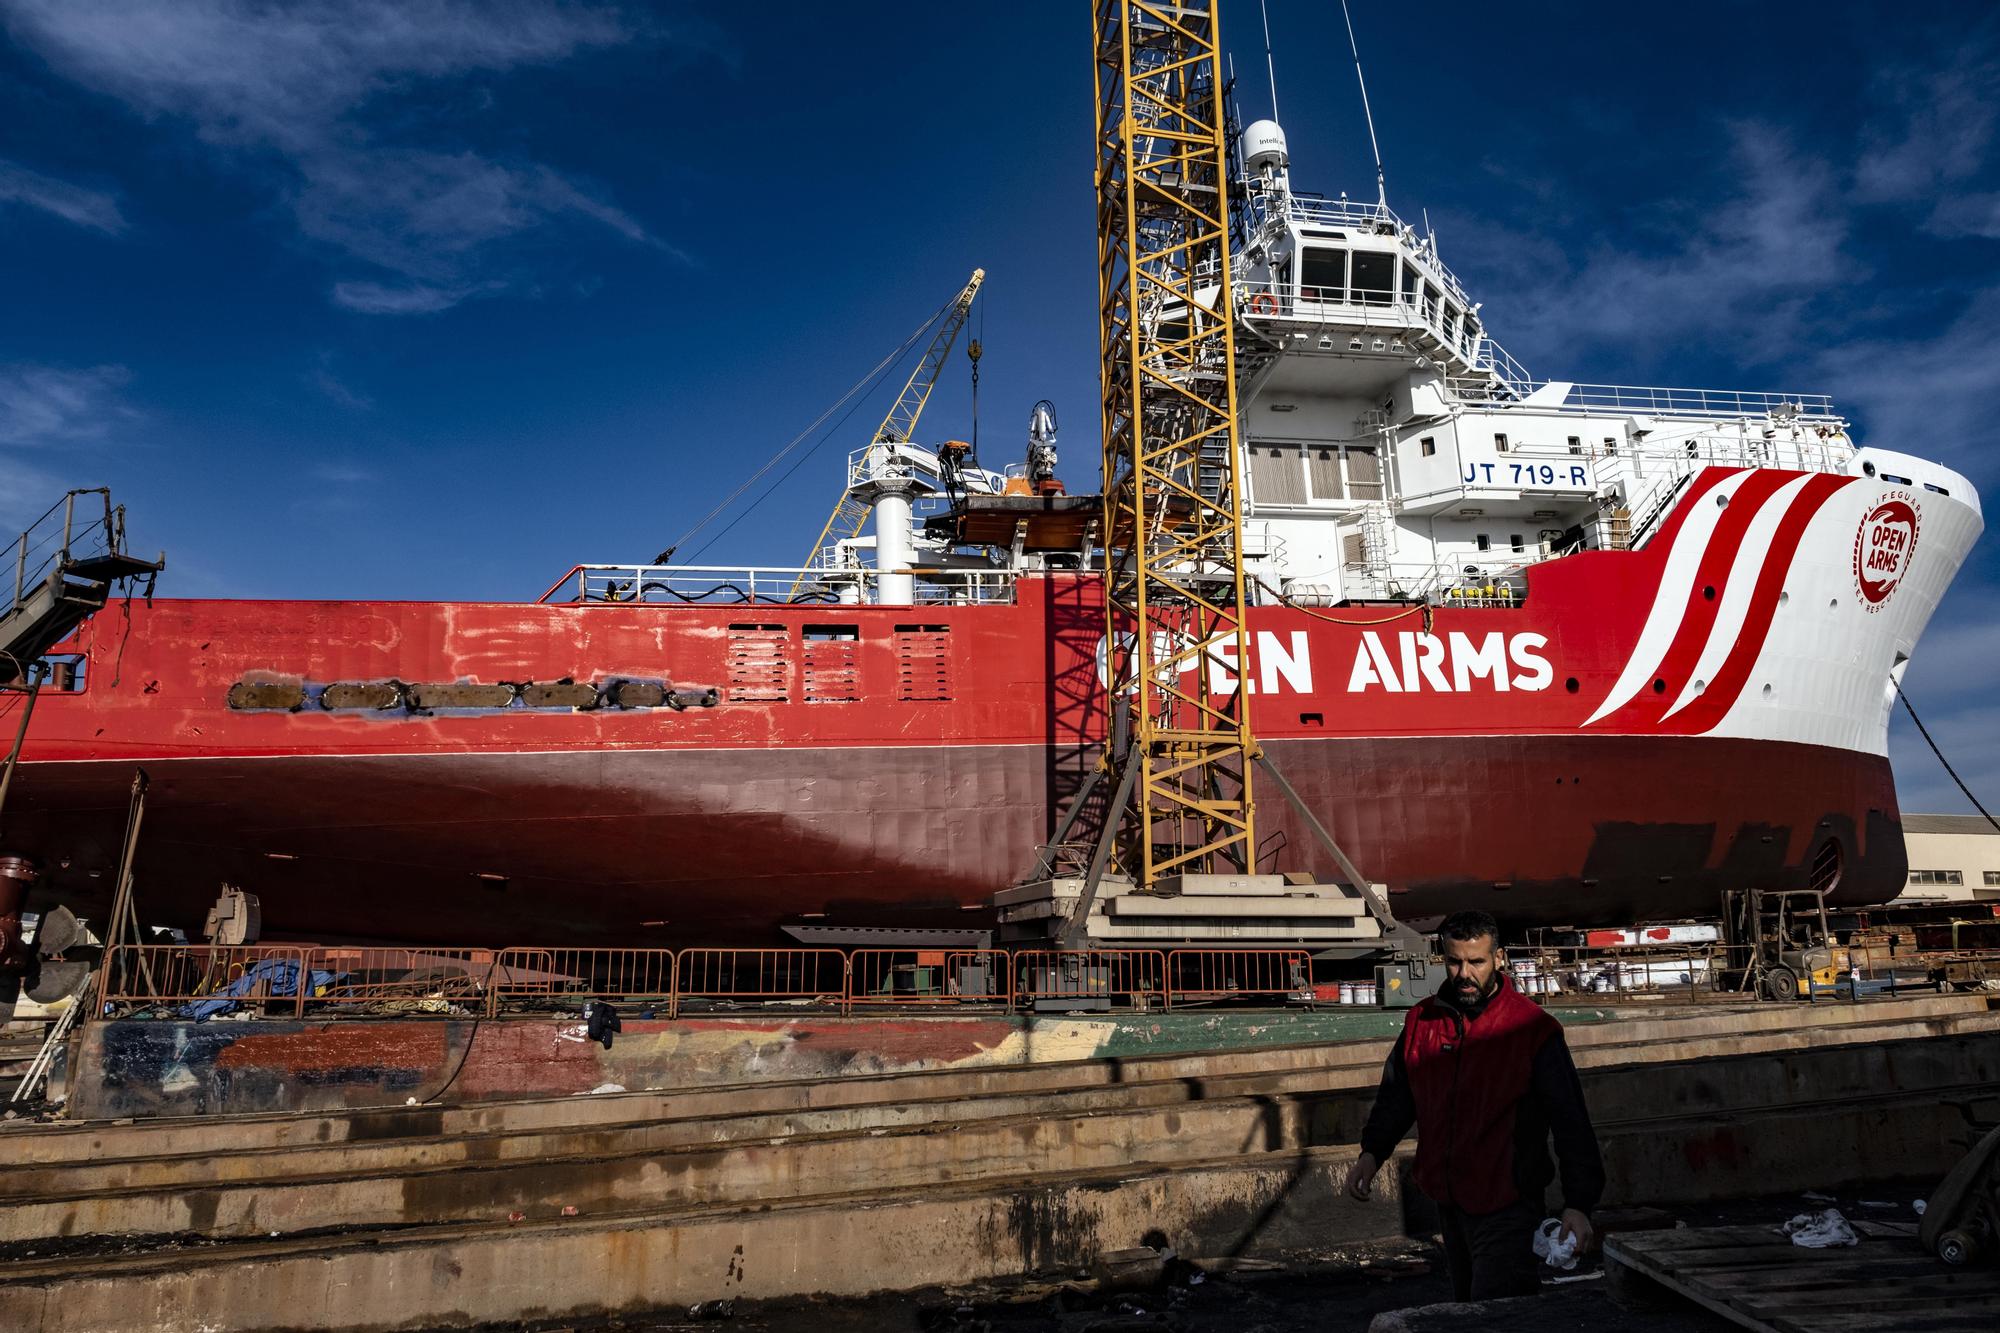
[536,564,1014,606]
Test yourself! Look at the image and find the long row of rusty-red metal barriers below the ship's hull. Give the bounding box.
[98,945,1344,1017]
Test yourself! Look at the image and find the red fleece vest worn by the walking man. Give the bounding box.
[1402,975,1560,1213]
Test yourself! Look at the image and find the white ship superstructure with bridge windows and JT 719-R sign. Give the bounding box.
[1236,120,1970,604]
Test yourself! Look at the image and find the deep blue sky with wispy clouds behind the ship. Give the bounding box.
[0,0,2000,811]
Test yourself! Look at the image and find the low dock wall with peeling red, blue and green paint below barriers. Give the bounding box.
[70,1009,1432,1119]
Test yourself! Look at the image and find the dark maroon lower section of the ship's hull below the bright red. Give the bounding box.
[8,737,1906,945]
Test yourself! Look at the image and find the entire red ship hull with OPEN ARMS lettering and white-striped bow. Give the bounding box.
[0,468,1980,945]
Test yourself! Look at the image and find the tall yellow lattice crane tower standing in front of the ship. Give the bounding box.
[1094,0,1256,889]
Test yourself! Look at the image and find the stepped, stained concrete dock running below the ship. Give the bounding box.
[0,995,2000,1333]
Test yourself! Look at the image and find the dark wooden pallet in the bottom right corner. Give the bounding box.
[1604,1219,2000,1333]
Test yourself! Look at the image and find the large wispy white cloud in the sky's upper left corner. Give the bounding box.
[0,0,668,314]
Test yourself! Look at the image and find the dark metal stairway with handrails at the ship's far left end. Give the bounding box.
[0,488,166,687]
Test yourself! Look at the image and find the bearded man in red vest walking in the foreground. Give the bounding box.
[1348,913,1604,1301]
